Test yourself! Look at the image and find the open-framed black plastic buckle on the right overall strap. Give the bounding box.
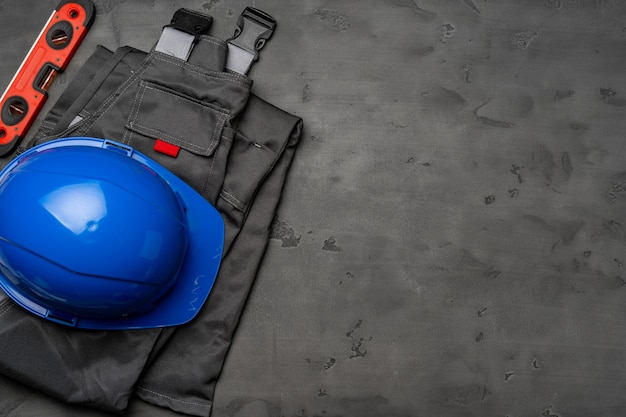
[228,7,276,61]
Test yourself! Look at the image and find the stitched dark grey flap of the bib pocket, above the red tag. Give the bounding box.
[126,81,229,156]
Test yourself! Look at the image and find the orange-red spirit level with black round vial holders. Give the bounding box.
[0,0,95,156]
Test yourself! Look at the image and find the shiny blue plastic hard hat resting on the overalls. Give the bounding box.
[0,138,224,330]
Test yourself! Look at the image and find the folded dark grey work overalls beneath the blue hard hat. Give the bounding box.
[0,30,302,416]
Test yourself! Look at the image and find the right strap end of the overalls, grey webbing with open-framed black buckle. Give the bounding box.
[226,7,276,75]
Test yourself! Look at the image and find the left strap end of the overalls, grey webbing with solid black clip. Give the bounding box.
[154,9,213,61]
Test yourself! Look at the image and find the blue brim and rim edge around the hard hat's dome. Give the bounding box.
[0,137,224,330]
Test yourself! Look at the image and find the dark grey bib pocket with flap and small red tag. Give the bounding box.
[123,80,234,203]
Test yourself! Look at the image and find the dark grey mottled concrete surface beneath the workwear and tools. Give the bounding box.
[0,0,626,417]
